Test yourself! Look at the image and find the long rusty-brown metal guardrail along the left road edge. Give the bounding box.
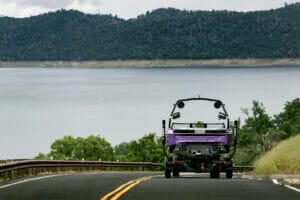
[0,160,163,182]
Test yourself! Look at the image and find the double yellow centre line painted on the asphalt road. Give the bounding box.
[100,176,153,200]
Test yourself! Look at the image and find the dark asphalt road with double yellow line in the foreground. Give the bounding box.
[0,172,300,200]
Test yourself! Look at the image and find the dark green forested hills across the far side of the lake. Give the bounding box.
[0,3,300,61]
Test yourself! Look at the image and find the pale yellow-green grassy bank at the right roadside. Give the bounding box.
[254,135,300,175]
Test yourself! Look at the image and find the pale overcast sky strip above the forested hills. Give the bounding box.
[0,0,300,19]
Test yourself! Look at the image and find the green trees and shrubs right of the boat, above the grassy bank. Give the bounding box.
[234,98,300,165]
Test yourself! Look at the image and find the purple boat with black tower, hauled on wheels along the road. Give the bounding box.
[162,97,238,178]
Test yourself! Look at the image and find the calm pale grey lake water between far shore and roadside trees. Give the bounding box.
[0,67,300,159]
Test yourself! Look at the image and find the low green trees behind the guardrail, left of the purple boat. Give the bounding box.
[36,133,164,163]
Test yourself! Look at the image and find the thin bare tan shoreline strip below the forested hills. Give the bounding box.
[0,58,300,68]
